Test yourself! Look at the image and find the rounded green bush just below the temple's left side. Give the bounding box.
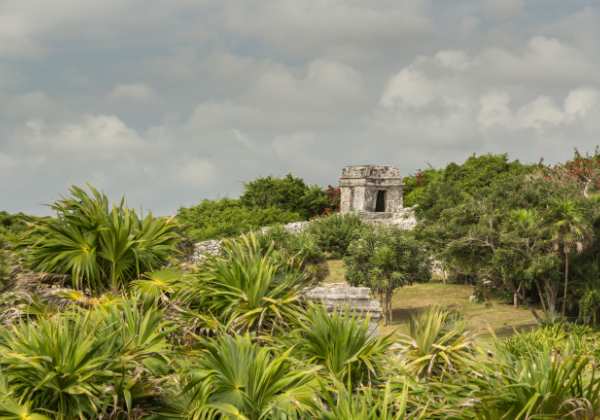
[308,214,366,258]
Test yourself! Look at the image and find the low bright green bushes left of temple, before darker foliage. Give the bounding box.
[177,198,302,242]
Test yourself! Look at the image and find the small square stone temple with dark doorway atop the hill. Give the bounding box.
[340,165,417,229]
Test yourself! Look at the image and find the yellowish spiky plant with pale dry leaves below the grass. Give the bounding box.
[399,307,475,377]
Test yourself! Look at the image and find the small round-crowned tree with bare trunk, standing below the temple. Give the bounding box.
[344,227,431,324]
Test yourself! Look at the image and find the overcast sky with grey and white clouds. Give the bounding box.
[0,0,600,214]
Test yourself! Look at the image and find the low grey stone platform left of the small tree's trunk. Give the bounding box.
[304,283,382,332]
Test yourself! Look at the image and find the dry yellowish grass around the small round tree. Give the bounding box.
[325,260,535,336]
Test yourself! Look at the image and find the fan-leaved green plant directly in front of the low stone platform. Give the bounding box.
[294,305,392,386]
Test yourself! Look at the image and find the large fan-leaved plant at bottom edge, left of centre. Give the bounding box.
[180,335,316,420]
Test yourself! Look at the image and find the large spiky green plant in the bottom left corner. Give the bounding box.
[0,314,119,419]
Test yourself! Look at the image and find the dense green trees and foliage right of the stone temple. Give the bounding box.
[410,154,600,322]
